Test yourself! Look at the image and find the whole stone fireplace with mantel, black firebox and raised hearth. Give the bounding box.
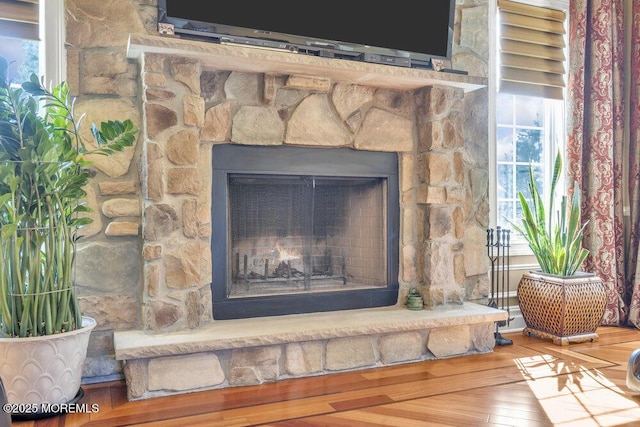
[114,35,507,399]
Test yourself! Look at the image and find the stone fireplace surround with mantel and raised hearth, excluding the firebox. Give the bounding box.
[114,35,500,399]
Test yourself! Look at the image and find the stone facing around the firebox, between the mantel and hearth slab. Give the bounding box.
[141,54,465,331]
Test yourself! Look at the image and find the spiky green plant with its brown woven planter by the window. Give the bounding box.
[512,151,607,345]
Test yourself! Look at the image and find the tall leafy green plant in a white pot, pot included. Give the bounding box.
[0,57,138,412]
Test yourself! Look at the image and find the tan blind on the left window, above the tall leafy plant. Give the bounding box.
[0,0,39,40]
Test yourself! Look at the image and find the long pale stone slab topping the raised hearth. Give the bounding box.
[114,302,508,360]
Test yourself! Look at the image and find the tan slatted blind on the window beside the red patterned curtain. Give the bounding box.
[498,0,566,99]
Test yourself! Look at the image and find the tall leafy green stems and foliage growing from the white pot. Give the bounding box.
[0,58,138,337]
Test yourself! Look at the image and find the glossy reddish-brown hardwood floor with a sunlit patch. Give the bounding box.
[13,327,640,427]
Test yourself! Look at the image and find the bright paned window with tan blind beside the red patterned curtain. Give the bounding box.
[490,0,568,255]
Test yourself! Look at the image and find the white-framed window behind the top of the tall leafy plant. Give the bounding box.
[0,0,66,84]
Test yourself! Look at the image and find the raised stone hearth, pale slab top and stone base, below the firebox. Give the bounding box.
[114,302,508,400]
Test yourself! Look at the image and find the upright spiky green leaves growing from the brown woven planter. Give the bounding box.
[510,152,589,276]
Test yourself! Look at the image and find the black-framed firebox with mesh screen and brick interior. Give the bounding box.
[212,144,399,319]
